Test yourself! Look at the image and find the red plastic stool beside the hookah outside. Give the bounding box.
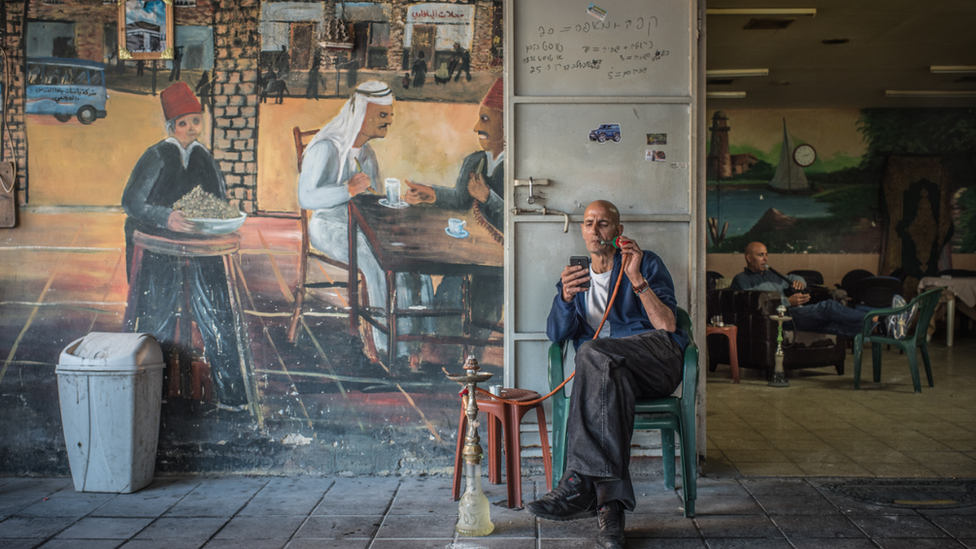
[452,389,552,509]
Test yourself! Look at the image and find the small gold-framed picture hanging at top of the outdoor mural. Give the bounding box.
[119,0,174,59]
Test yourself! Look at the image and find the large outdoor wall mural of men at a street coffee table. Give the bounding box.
[0,0,505,474]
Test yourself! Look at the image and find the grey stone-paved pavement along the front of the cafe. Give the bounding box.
[0,476,976,549]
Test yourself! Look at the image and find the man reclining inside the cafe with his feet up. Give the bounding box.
[730,242,864,338]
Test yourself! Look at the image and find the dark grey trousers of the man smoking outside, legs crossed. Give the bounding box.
[566,330,683,511]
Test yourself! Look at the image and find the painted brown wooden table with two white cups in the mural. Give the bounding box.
[349,195,504,369]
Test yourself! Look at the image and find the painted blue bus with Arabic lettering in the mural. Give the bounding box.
[27,57,108,124]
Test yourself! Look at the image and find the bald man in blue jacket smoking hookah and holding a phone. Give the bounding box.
[526,200,689,549]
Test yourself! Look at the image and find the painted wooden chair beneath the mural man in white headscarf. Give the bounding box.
[288,126,379,362]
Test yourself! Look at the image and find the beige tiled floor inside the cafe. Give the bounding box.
[706,330,976,477]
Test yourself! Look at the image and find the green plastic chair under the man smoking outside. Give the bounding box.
[549,308,698,518]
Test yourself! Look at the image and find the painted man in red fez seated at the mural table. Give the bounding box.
[404,78,505,360]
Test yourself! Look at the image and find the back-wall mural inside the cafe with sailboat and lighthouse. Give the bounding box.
[707,109,976,253]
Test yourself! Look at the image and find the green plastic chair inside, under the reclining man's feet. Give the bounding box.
[854,288,943,393]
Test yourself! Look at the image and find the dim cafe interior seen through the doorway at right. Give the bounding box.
[703,0,976,477]
